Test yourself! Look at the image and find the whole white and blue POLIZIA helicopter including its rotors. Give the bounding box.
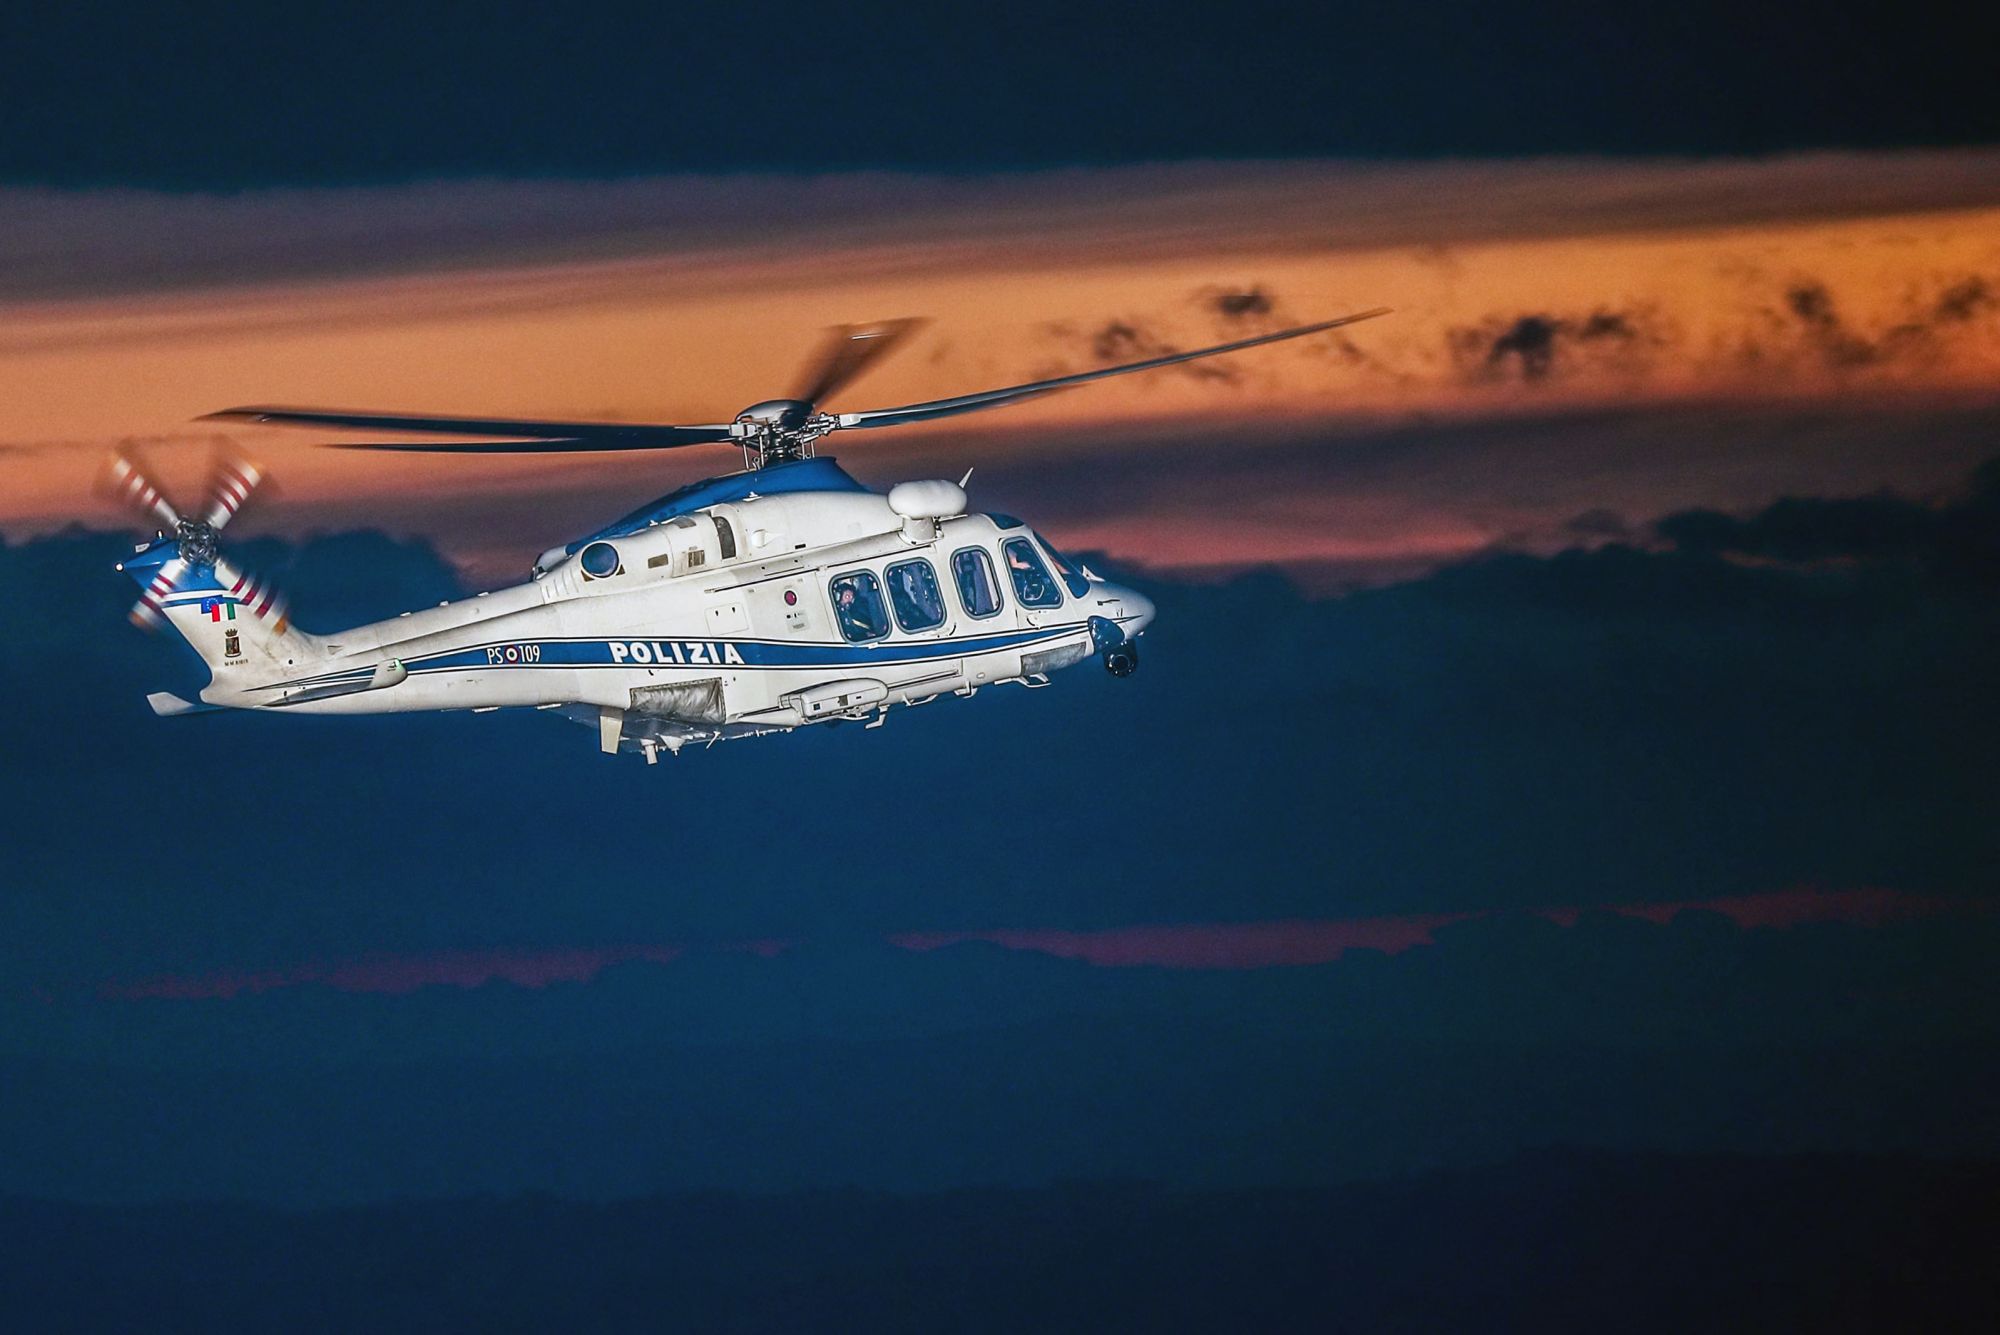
[106,308,1388,763]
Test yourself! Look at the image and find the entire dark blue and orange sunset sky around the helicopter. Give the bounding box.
[0,4,2000,1329]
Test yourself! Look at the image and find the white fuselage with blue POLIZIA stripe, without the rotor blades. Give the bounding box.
[166,460,1152,759]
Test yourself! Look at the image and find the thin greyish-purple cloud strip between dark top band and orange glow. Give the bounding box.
[11,150,2000,302]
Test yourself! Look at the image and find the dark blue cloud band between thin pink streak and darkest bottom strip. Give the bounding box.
[0,911,2000,1205]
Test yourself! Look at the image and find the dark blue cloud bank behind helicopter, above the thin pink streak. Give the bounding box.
[0,453,2000,983]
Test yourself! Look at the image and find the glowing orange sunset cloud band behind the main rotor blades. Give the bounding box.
[0,152,2000,579]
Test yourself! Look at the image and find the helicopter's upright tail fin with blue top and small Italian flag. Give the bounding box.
[118,538,324,693]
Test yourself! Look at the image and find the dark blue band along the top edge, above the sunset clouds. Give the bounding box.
[0,0,2000,188]
